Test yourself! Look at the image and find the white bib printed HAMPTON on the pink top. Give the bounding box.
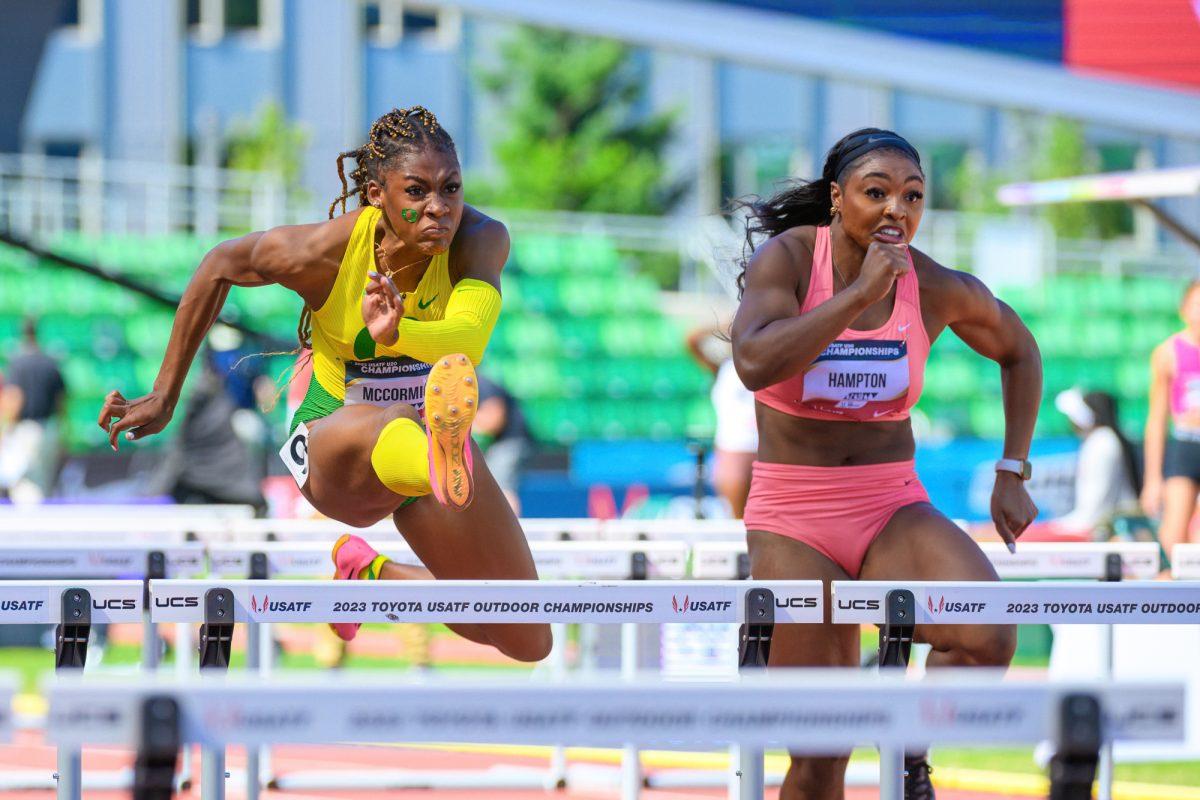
[800,339,908,414]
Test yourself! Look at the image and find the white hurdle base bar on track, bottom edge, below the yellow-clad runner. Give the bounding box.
[266,765,560,792]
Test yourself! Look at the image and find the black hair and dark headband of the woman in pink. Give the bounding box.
[734,128,920,297]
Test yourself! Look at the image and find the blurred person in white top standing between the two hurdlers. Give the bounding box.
[688,327,758,519]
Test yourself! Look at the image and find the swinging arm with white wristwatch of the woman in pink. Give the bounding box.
[943,270,1042,545]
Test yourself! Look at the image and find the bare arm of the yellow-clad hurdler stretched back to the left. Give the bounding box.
[98,223,340,450]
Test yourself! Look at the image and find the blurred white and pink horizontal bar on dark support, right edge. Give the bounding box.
[996,166,1200,249]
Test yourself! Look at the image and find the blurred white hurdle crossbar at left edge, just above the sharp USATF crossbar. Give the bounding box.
[0,542,206,579]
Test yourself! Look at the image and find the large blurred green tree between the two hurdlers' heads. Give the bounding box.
[472,28,684,215]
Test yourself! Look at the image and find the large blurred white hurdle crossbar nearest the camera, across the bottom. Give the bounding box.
[48,670,1183,800]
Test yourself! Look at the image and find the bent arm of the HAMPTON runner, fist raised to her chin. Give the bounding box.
[732,236,912,391]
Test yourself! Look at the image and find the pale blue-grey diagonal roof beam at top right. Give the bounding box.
[439,0,1200,139]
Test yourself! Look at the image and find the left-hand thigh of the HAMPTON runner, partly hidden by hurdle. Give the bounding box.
[746,530,858,667]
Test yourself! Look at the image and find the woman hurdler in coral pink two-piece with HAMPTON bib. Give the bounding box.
[733,128,1042,800]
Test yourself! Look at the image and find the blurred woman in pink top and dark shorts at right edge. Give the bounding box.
[1141,281,1200,558]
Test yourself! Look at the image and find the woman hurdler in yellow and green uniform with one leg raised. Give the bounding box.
[100,107,551,661]
